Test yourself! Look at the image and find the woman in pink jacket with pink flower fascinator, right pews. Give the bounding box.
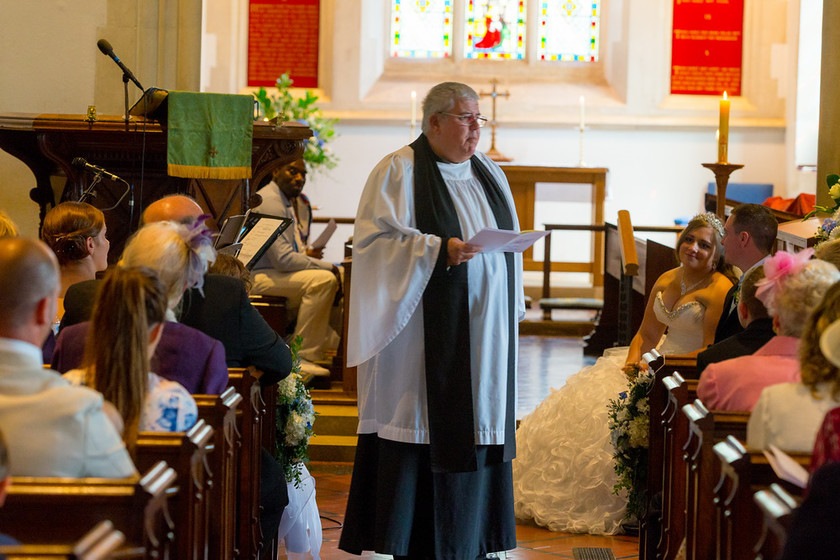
[697,249,840,411]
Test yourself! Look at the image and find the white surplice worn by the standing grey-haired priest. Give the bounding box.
[347,146,525,445]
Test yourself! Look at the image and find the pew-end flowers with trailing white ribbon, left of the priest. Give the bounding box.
[275,337,322,560]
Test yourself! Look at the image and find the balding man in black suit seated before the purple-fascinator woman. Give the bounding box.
[62,195,292,386]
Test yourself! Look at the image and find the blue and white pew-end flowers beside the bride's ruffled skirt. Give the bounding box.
[607,366,653,518]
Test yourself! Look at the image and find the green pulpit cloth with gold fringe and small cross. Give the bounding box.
[166,91,254,179]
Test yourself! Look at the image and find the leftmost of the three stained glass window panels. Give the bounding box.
[391,0,453,58]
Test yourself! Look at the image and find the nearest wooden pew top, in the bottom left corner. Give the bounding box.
[0,520,141,560]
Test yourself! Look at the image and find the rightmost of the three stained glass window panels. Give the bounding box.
[537,0,601,62]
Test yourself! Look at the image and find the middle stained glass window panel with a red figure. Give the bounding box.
[464,0,526,60]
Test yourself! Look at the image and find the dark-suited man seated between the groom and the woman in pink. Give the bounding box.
[697,265,775,374]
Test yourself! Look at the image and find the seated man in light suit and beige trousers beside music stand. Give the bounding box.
[251,159,341,375]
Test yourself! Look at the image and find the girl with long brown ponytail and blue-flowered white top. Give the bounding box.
[64,267,198,449]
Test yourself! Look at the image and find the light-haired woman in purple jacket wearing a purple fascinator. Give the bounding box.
[52,222,228,395]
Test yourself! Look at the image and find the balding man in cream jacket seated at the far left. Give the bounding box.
[0,238,136,478]
